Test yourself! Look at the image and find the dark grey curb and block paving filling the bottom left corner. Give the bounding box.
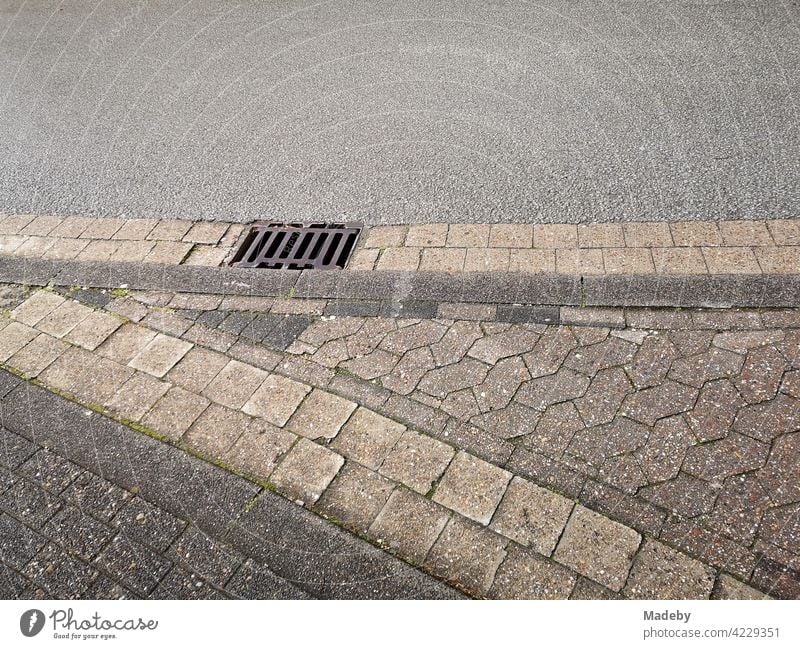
[0,370,459,599]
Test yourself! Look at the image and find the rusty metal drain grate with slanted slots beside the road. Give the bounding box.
[231,222,364,270]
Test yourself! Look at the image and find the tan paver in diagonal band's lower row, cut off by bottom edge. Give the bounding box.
[489,547,575,600]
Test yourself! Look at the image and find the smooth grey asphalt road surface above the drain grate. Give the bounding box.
[0,0,800,223]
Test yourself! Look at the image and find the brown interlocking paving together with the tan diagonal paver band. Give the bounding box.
[0,288,800,598]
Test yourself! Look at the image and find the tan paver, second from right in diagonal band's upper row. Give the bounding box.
[623,539,716,599]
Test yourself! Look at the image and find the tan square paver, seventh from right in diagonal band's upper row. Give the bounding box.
[331,408,406,471]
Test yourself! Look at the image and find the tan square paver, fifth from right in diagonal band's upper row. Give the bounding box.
[433,451,512,525]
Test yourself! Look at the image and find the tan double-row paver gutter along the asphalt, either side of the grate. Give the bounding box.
[0,215,800,276]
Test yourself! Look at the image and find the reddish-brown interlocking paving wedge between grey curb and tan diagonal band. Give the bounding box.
[103,291,800,597]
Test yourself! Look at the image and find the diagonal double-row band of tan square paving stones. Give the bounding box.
[0,291,776,598]
